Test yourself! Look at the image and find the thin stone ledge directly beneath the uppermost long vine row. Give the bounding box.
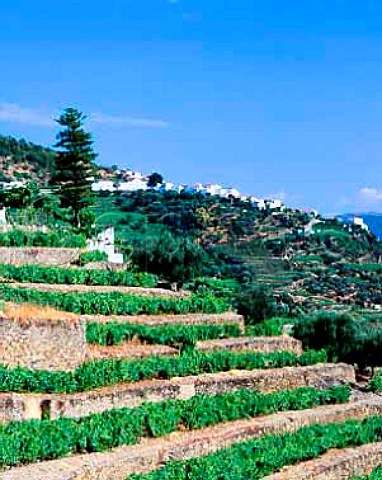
[2,282,190,298]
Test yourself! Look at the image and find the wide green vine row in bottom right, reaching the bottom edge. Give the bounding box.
[128,417,382,480]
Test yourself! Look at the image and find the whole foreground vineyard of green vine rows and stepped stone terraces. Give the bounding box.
[0,260,382,480]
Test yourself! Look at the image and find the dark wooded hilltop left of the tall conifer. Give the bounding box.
[0,135,54,184]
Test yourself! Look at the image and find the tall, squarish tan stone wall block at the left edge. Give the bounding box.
[0,315,86,371]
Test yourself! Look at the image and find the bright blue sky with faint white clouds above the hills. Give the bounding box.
[0,0,382,213]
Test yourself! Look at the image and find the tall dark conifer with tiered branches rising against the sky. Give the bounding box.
[51,108,97,226]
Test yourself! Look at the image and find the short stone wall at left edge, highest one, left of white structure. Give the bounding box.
[0,247,82,267]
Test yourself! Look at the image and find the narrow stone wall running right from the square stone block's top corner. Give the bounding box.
[81,312,245,333]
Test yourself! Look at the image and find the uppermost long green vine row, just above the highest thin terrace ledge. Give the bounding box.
[0,264,158,288]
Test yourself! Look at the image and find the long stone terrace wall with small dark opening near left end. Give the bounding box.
[0,363,355,423]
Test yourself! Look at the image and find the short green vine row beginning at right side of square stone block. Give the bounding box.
[86,322,241,349]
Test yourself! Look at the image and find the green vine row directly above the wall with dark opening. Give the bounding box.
[0,350,327,393]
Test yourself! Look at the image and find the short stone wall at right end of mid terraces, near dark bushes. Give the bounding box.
[196,335,303,354]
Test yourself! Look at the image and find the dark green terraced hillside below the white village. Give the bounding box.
[97,191,382,308]
